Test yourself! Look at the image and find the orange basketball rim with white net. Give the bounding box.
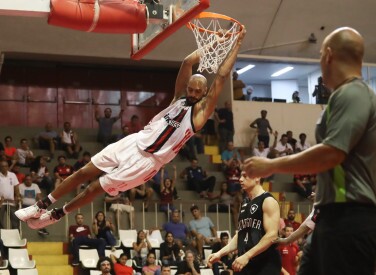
[187,12,243,73]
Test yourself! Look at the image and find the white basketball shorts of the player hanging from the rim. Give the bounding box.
[91,134,162,196]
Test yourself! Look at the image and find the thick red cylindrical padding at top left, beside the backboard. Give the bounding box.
[48,0,147,34]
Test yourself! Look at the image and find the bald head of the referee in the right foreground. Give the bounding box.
[323,27,364,65]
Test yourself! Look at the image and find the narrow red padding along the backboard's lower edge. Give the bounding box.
[131,0,210,60]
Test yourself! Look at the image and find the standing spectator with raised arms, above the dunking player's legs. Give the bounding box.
[95,107,124,147]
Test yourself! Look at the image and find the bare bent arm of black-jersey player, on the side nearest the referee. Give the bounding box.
[245,197,280,260]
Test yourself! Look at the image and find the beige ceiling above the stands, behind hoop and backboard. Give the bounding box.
[0,0,376,77]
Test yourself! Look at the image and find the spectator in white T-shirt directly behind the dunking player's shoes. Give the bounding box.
[18,175,50,235]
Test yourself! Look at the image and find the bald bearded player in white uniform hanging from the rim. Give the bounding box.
[16,27,246,229]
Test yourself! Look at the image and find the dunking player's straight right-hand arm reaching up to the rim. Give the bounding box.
[194,26,246,130]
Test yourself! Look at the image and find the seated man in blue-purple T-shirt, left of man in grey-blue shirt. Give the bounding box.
[161,210,189,249]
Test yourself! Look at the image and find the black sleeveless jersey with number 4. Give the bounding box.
[238,192,275,260]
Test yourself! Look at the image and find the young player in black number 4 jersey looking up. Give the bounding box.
[208,172,281,275]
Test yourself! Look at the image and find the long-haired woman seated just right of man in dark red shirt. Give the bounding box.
[92,211,116,251]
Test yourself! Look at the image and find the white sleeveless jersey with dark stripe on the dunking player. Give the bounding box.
[137,97,195,163]
